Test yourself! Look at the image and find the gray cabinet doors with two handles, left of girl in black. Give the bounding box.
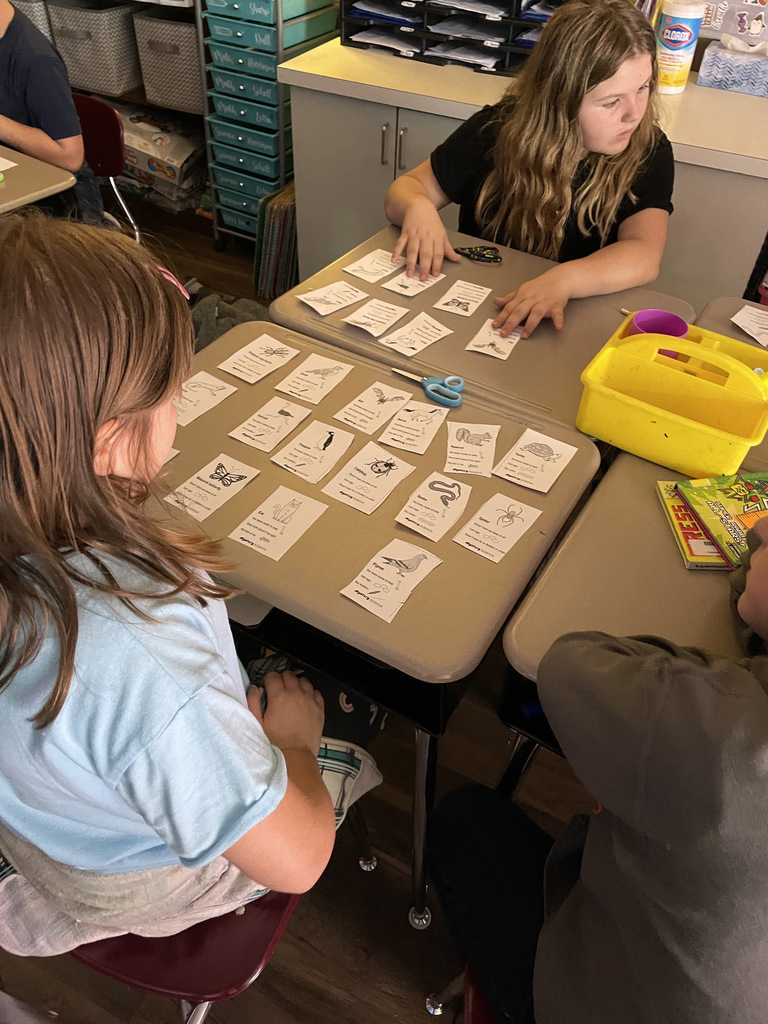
[291,87,461,281]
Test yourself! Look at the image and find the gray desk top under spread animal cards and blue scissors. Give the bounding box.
[156,323,598,682]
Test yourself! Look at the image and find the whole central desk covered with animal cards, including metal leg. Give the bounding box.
[160,323,599,927]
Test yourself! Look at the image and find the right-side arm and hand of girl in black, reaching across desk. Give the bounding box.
[493,207,670,338]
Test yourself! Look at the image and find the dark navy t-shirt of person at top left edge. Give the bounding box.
[0,10,81,141]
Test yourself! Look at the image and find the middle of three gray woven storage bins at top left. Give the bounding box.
[48,0,141,96]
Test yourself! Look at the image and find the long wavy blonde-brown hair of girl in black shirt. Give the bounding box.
[476,0,656,259]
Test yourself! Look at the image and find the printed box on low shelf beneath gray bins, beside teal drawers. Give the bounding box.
[112,103,205,189]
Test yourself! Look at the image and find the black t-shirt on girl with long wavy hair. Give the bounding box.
[431,106,675,263]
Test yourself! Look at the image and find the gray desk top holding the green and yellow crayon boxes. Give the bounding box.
[504,298,768,679]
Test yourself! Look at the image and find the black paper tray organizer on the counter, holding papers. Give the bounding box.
[341,0,564,75]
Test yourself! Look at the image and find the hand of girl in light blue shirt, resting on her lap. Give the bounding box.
[253,672,326,757]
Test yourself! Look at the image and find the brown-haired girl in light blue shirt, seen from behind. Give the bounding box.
[0,213,334,954]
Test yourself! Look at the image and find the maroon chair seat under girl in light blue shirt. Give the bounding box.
[70,892,299,1024]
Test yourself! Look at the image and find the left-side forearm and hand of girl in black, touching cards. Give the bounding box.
[384,160,461,281]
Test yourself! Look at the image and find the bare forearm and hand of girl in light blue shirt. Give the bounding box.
[224,672,336,893]
